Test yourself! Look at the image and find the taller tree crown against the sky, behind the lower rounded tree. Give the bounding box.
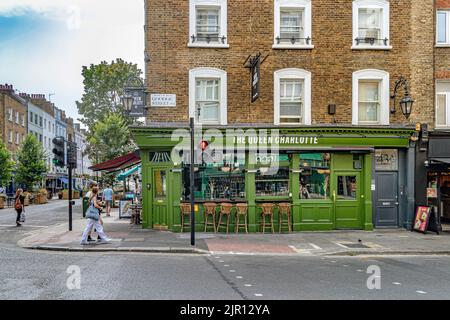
[76,59,142,132]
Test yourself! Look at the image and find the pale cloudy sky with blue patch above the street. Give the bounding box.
[0,0,145,125]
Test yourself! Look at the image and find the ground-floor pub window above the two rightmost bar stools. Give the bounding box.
[255,166,289,197]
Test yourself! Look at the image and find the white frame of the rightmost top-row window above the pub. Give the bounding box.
[352,0,392,50]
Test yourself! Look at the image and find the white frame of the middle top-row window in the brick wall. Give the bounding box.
[272,0,314,49]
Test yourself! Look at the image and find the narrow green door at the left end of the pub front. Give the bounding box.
[151,168,169,230]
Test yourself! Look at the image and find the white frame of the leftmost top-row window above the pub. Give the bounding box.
[188,0,230,49]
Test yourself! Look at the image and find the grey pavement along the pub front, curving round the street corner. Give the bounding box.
[17,211,450,256]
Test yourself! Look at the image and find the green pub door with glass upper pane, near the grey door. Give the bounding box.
[333,171,363,229]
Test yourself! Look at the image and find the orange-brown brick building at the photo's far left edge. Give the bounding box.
[0,84,28,154]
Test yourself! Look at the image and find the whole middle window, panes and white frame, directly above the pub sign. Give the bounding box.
[274,69,311,125]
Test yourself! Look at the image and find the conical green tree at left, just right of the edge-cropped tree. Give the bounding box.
[15,134,47,191]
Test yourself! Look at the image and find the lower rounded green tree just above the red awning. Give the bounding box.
[88,113,136,163]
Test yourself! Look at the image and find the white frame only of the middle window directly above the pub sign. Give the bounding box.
[273,68,311,126]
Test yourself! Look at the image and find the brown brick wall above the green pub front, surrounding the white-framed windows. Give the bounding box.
[146,0,435,124]
